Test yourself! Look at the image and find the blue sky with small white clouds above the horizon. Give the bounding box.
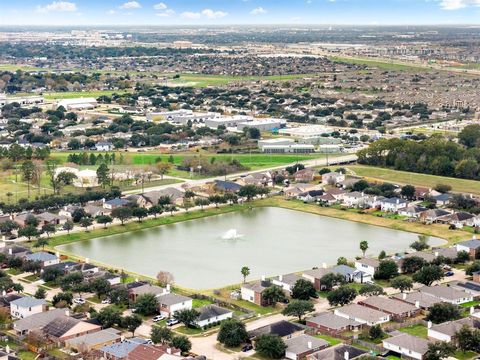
[0,0,480,26]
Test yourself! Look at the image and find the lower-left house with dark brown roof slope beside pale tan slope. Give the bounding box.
[42,315,102,344]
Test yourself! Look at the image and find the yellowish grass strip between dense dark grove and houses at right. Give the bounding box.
[348,165,480,195]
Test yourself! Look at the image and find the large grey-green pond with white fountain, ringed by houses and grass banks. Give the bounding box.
[58,207,444,289]
